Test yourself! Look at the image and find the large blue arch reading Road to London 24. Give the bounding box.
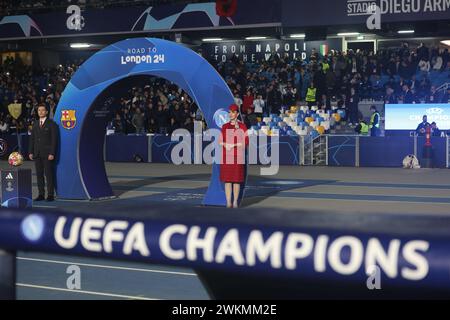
[55,38,234,206]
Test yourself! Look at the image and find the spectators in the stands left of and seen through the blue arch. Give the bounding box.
[0,54,203,134]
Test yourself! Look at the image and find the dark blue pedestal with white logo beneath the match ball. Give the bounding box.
[1,168,33,209]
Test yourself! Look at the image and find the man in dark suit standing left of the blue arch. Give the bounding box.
[29,104,58,201]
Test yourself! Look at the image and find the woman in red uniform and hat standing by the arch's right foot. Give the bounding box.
[220,104,248,208]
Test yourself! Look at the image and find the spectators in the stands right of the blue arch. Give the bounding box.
[217,43,450,123]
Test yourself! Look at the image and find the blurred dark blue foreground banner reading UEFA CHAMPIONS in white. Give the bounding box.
[0,209,450,291]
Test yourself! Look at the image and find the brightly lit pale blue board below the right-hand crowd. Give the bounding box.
[385,104,450,130]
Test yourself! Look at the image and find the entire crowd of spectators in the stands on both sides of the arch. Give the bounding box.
[0,44,450,134]
